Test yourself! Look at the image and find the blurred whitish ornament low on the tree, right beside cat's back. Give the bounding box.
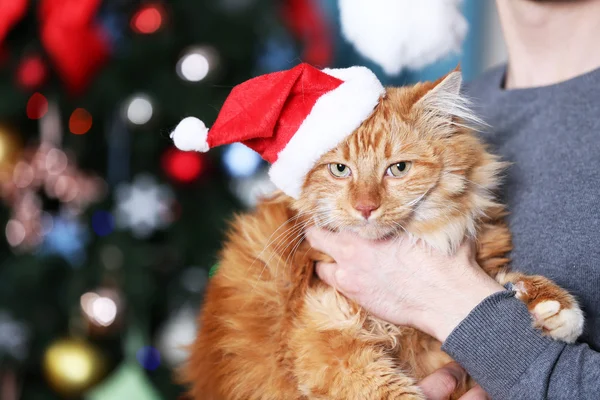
[156,306,198,368]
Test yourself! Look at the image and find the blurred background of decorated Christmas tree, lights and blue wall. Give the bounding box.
[0,0,505,400]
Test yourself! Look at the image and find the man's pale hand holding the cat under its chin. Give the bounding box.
[307,228,504,342]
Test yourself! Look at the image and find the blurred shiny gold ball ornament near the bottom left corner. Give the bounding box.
[44,339,107,396]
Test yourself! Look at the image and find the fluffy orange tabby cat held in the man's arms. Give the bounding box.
[183,72,583,400]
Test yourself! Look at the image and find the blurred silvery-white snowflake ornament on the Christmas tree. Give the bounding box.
[115,175,173,238]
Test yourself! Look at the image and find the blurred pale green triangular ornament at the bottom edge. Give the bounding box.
[84,361,162,400]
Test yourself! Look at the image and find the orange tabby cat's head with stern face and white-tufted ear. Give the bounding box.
[297,73,502,249]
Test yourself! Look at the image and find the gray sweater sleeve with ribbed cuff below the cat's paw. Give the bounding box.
[442,291,600,400]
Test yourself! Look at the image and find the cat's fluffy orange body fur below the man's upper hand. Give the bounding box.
[184,197,474,400]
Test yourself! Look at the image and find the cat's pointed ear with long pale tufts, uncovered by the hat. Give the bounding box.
[413,66,483,133]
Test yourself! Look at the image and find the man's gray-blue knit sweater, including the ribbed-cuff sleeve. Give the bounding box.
[443,67,600,400]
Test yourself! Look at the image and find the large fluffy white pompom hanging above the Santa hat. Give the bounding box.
[339,0,467,75]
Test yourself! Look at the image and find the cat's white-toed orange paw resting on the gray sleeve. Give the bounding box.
[513,276,584,343]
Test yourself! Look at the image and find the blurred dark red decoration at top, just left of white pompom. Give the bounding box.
[282,0,333,67]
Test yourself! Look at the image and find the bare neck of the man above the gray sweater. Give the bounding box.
[496,0,600,89]
